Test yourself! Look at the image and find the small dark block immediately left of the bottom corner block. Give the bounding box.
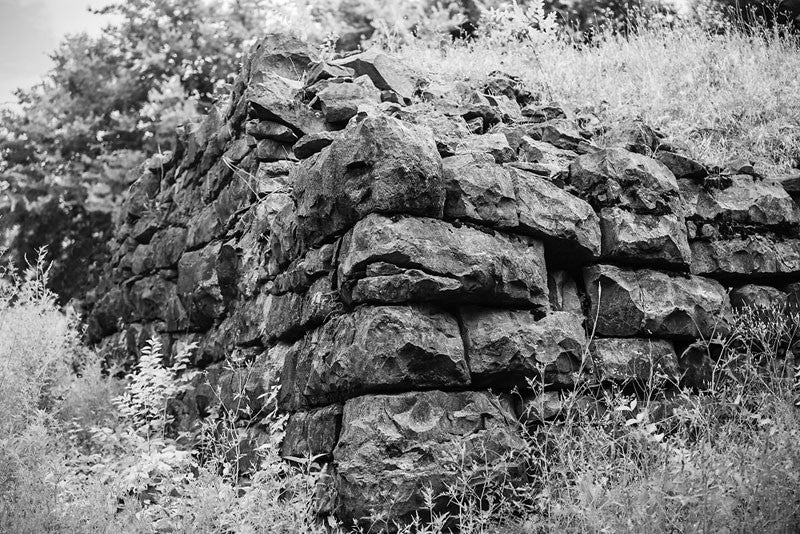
[281,404,342,461]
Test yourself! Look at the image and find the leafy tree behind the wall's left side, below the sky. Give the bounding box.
[0,0,266,301]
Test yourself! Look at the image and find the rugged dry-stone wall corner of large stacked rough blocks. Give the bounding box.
[89,36,800,532]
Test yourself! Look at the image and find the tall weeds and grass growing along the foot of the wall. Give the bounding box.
[0,253,800,534]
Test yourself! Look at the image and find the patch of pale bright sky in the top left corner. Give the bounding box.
[0,0,114,105]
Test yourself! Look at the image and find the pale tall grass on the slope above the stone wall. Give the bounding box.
[396,14,800,173]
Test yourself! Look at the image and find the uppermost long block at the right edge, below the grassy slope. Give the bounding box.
[680,174,800,231]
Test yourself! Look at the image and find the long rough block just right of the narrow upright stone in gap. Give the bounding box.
[584,265,730,339]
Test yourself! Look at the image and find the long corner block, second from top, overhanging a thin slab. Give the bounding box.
[339,214,548,310]
